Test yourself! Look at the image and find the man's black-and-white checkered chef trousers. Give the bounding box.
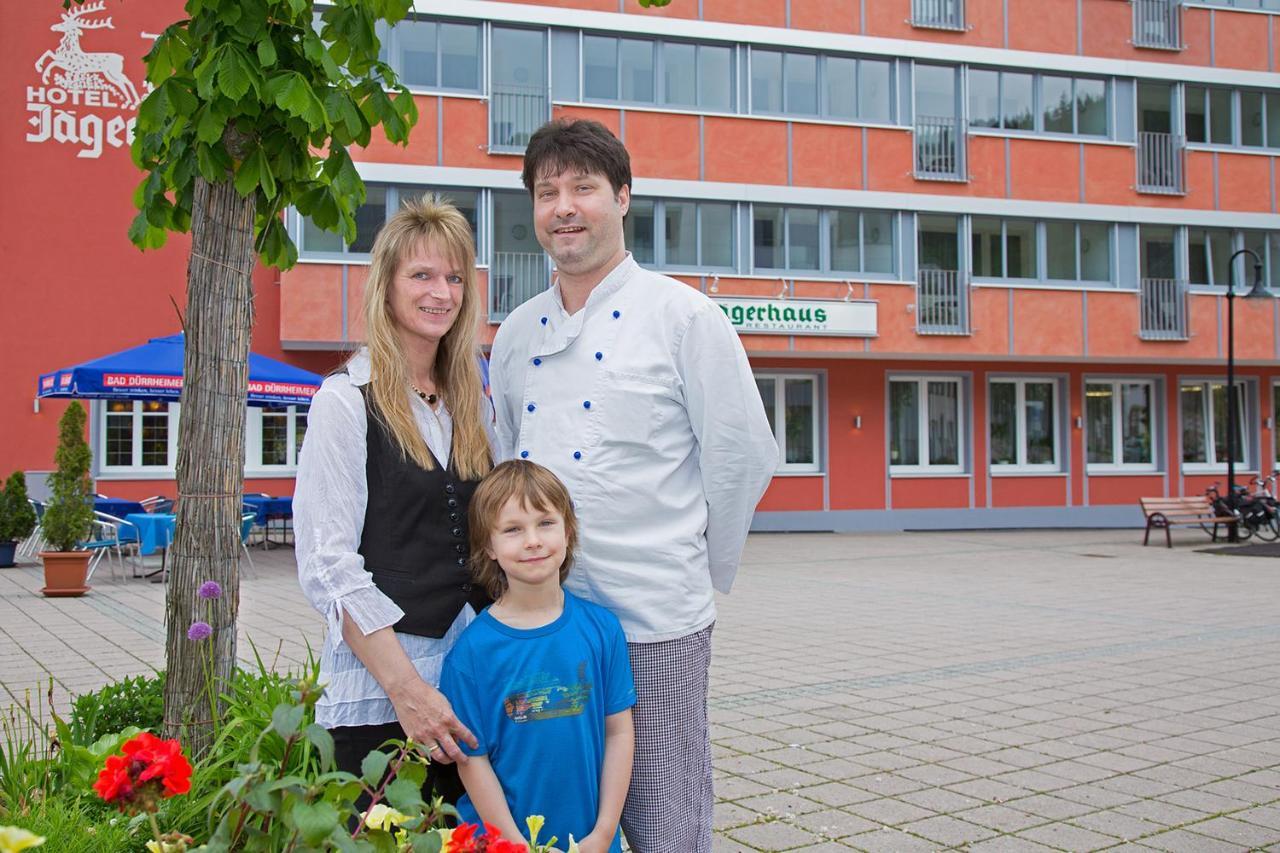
[622,625,716,853]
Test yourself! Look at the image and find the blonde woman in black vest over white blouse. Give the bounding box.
[293,196,493,802]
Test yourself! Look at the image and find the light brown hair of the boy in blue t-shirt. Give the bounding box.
[467,459,577,601]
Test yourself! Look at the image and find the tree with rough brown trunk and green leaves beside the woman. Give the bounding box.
[63,0,417,756]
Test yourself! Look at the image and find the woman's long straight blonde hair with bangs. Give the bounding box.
[364,193,493,480]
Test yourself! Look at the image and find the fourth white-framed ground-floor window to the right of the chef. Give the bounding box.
[1084,379,1156,471]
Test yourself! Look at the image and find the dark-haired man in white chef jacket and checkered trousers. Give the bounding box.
[490,120,778,853]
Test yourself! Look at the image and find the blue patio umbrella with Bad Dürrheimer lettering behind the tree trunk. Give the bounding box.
[36,333,323,406]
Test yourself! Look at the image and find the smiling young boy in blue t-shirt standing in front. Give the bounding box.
[440,460,635,853]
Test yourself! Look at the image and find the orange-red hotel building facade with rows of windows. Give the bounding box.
[0,0,1280,530]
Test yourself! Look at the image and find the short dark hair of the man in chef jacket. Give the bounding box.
[520,119,631,196]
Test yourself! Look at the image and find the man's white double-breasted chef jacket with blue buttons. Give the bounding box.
[489,254,778,643]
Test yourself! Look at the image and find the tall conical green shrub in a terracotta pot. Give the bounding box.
[40,402,93,596]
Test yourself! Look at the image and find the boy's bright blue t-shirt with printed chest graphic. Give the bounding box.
[440,590,636,853]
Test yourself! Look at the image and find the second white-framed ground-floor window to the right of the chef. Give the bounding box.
[888,377,964,474]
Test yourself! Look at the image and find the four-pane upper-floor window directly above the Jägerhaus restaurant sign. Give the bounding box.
[751,205,893,275]
